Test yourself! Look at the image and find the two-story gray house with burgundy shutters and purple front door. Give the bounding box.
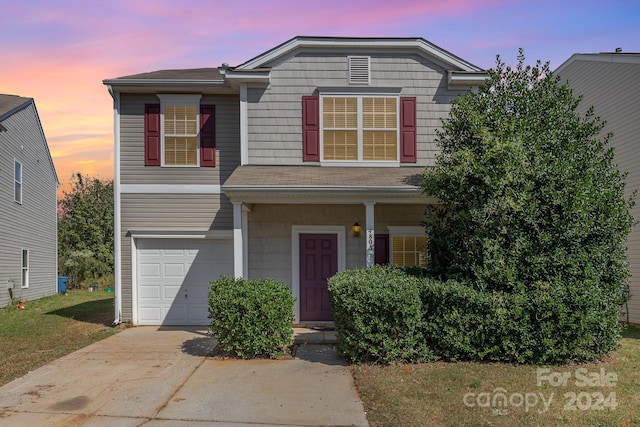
[103,37,487,325]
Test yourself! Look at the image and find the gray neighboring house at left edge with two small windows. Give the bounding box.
[0,94,58,307]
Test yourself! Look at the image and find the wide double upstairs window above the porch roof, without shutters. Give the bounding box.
[322,96,398,161]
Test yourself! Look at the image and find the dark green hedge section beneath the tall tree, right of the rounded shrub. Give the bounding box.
[421,279,617,363]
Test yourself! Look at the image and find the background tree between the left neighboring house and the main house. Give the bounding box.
[58,173,113,286]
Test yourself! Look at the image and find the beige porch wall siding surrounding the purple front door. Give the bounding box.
[248,204,424,288]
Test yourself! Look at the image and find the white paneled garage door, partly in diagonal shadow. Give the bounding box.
[136,239,233,325]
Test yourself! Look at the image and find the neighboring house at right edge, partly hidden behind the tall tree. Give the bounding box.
[554,52,640,324]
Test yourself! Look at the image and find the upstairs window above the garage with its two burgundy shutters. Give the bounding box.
[144,95,216,167]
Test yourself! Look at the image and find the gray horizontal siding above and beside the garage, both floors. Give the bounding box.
[120,94,240,321]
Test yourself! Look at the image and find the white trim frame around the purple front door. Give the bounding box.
[291,225,347,323]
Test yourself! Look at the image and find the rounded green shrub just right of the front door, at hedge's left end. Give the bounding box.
[329,266,429,362]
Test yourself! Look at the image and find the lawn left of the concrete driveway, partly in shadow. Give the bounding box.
[0,290,118,385]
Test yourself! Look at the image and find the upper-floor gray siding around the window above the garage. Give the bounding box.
[120,94,240,185]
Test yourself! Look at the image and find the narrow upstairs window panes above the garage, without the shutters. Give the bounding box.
[163,104,198,166]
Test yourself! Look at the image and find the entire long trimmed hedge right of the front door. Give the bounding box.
[329,266,621,364]
